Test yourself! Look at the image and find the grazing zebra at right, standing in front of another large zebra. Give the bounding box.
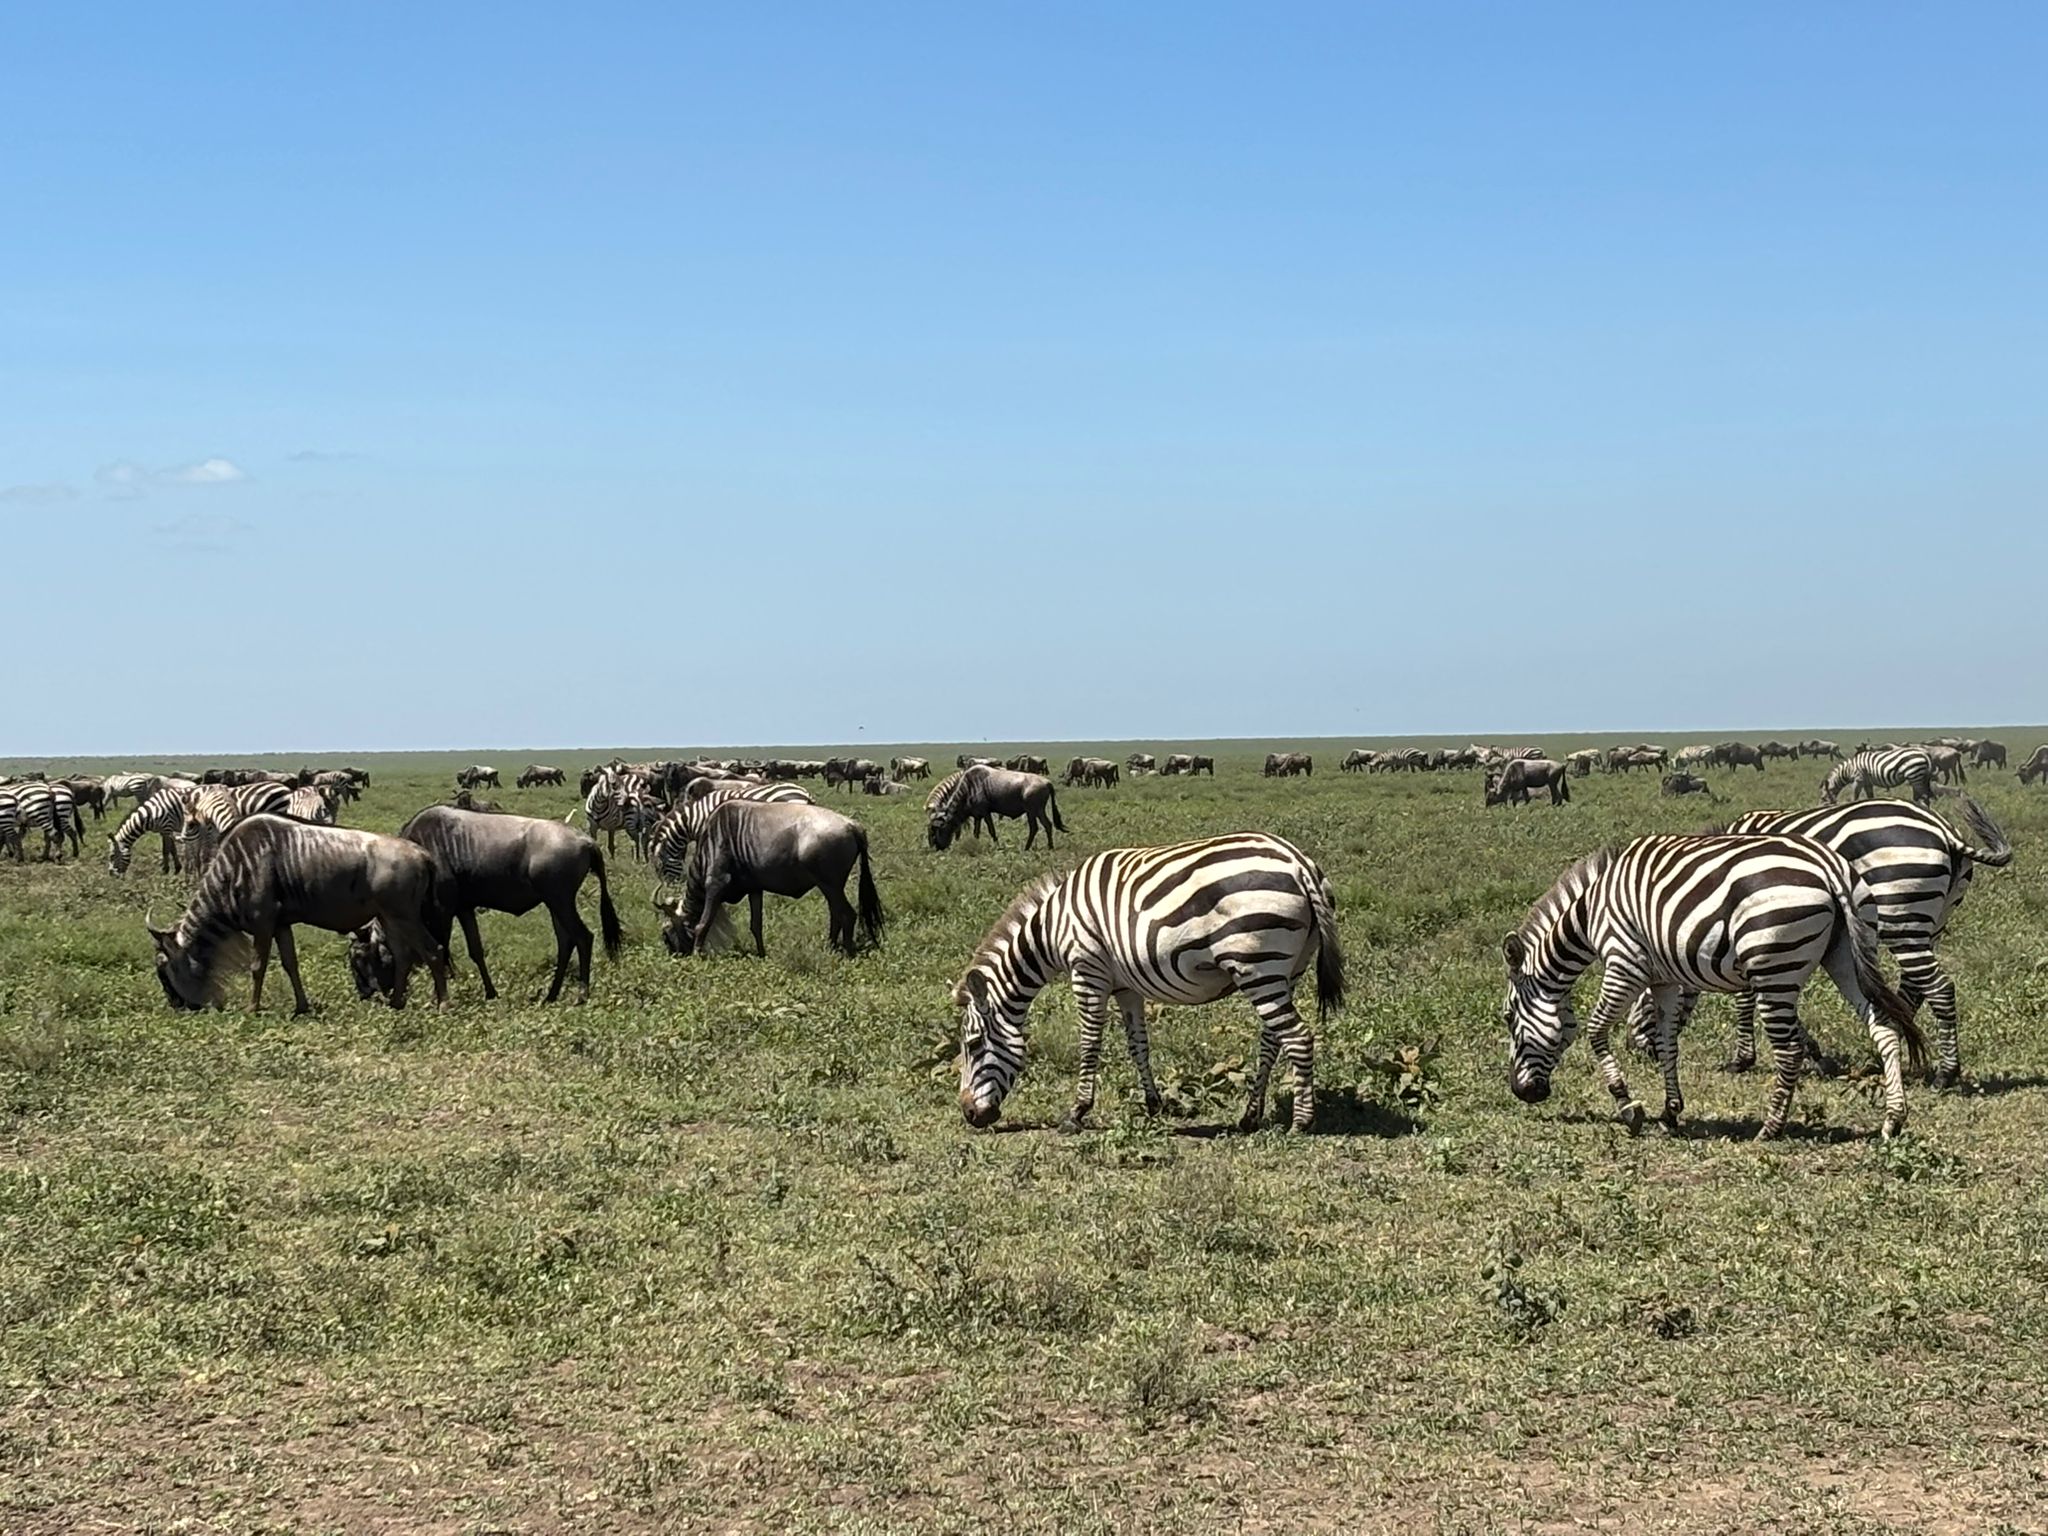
[1501,834,1927,1141]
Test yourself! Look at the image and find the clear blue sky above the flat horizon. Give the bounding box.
[0,4,2048,754]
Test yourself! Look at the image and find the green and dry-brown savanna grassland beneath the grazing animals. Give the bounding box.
[12,731,2048,1536]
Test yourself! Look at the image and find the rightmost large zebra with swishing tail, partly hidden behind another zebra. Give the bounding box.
[1634,795,2013,1087]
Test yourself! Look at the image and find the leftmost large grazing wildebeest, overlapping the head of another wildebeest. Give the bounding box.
[150,815,449,1014]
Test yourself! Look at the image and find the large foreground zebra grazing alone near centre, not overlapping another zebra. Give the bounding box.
[952,831,1343,1130]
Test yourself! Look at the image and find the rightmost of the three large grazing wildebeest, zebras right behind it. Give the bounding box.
[657,801,887,954]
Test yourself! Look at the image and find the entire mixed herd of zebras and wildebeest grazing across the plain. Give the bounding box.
[0,739,2048,1137]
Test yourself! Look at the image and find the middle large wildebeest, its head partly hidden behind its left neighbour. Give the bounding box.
[348,805,625,1004]
